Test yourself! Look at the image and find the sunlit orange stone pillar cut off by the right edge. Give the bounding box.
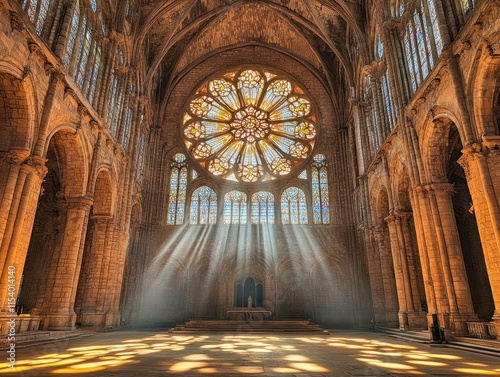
[458,142,500,334]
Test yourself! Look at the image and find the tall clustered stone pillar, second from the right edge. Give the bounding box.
[425,183,476,336]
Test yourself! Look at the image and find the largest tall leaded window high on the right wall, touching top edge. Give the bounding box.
[404,0,443,92]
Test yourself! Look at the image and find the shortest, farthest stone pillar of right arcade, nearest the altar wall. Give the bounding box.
[371,225,398,327]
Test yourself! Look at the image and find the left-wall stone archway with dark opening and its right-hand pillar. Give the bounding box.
[19,129,91,329]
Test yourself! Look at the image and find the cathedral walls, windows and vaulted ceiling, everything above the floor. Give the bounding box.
[0,0,500,339]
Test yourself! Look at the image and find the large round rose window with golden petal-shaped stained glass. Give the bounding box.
[183,69,316,182]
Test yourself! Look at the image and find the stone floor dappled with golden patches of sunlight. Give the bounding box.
[0,330,500,377]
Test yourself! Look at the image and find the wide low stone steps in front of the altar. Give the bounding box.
[171,319,328,334]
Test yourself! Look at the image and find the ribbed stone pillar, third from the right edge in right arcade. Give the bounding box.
[385,212,425,330]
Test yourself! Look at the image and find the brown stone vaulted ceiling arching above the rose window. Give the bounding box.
[133,0,368,110]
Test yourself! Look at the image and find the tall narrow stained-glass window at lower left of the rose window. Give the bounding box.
[168,153,188,225]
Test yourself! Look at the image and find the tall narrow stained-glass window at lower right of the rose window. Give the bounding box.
[311,154,330,224]
